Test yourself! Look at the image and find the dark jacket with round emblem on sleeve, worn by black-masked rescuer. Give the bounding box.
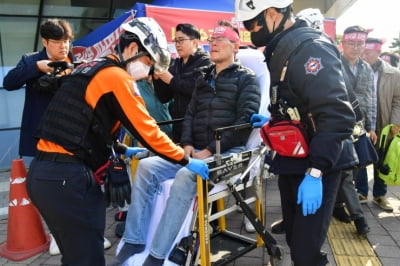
[266,21,357,174]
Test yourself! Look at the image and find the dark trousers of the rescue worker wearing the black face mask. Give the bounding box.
[278,171,341,266]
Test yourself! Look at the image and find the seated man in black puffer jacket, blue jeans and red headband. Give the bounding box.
[109,21,260,266]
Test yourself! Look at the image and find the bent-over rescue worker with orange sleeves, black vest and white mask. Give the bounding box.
[27,18,208,266]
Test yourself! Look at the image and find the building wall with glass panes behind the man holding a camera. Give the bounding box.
[0,0,152,171]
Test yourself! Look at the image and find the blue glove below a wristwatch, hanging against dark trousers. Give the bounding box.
[297,174,322,216]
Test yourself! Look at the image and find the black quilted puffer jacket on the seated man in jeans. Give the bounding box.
[181,63,260,153]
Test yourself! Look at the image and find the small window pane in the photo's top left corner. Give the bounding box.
[0,0,40,15]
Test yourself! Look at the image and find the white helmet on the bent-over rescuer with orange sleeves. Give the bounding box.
[121,17,171,72]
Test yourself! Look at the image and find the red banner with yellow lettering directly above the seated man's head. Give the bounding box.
[146,5,251,45]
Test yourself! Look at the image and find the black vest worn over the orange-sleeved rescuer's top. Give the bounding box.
[36,58,123,170]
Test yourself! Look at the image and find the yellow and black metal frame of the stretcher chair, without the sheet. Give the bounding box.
[181,124,284,266]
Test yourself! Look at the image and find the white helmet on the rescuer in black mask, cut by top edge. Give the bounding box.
[235,0,293,21]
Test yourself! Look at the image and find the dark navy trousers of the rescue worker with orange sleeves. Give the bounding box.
[27,159,105,266]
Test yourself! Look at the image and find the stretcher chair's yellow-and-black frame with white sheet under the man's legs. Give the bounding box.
[117,124,284,266]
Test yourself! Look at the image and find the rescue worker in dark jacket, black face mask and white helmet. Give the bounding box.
[235,0,357,266]
